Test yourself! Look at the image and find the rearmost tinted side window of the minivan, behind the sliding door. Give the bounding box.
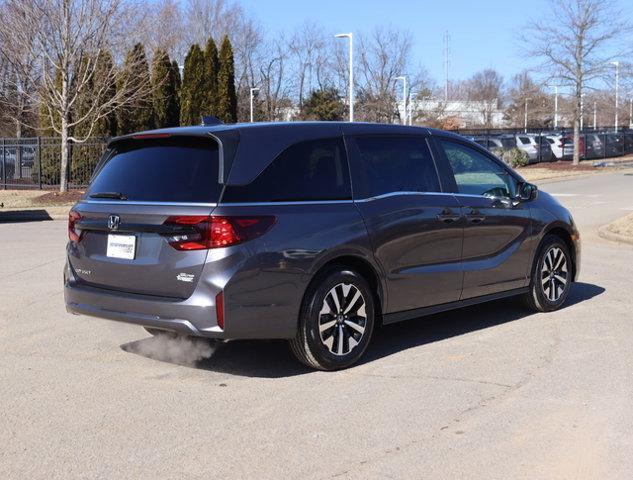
[222,138,352,202]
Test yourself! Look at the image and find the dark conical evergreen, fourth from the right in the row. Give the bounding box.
[152,50,180,128]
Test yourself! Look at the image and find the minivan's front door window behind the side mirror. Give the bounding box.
[440,140,516,197]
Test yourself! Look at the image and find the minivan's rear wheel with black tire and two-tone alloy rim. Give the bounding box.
[290,266,375,370]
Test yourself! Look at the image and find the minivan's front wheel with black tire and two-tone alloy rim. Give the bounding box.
[523,235,573,312]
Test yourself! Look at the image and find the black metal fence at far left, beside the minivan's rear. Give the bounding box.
[0,137,107,189]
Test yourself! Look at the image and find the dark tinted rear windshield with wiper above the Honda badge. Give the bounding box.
[87,138,221,203]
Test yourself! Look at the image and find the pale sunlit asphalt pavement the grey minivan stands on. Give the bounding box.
[0,172,633,479]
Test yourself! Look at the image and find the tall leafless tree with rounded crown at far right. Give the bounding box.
[524,0,631,165]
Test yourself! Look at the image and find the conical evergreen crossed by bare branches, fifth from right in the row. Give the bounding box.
[117,43,154,135]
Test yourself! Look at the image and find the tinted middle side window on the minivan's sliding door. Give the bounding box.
[356,136,440,198]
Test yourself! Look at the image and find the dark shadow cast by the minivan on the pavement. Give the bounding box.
[121,283,605,378]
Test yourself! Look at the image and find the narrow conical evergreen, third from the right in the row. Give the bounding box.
[180,44,206,125]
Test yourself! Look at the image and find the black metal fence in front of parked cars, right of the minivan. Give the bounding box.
[454,127,633,163]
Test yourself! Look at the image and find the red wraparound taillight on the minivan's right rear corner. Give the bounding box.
[165,215,275,250]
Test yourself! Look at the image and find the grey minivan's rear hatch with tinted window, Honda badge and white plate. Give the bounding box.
[68,135,222,298]
